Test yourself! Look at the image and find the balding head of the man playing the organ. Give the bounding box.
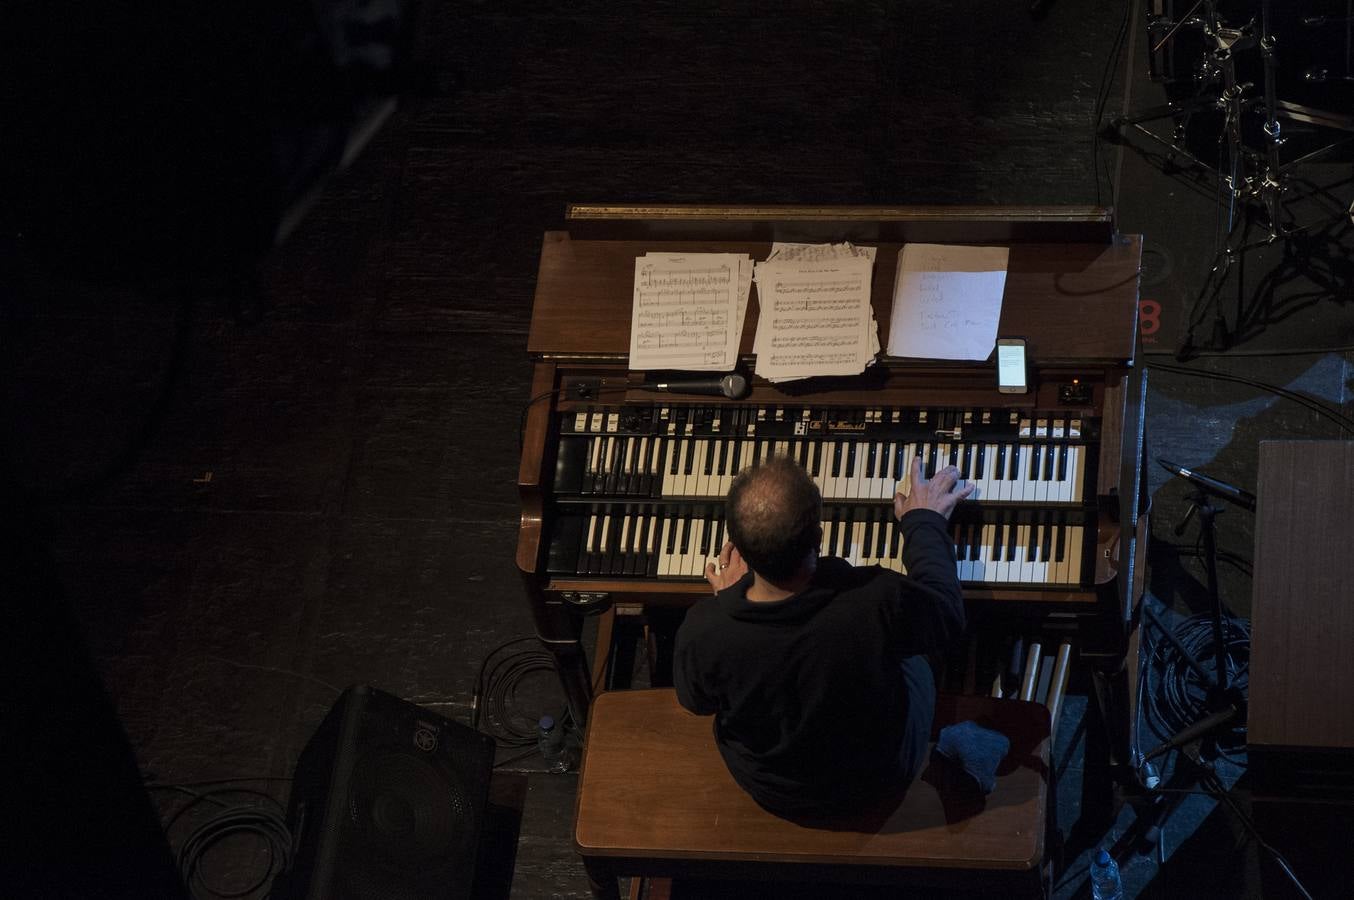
[724,457,823,581]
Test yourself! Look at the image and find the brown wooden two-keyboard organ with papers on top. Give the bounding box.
[517,207,1145,716]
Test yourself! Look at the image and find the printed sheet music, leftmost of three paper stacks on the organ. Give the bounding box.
[630,253,751,372]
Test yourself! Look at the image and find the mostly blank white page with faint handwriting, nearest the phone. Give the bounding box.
[888,244,1010,360]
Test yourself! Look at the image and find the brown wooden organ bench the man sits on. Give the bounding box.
[574,690,1051,900]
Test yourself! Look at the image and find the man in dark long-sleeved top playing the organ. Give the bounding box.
[673,457,974,815]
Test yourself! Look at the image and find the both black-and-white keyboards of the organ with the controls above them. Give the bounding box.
[546,403,1099,586]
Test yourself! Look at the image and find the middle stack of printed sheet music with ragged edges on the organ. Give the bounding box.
[754,256,877,382]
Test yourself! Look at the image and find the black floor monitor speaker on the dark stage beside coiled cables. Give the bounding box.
[272,686,494,900]
